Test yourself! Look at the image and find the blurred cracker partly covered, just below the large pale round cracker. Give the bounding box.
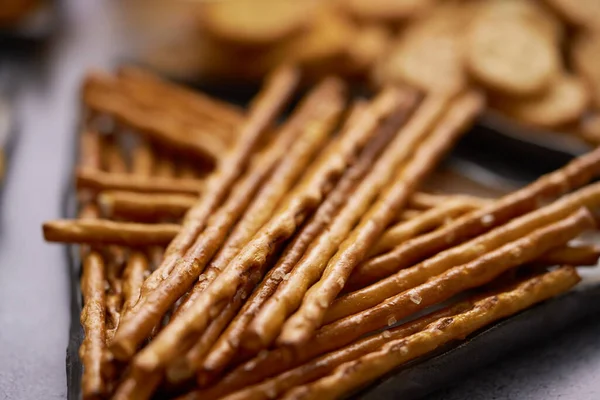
[501,74,589,128]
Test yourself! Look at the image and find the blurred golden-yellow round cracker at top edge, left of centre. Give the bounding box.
[200,0,314,46]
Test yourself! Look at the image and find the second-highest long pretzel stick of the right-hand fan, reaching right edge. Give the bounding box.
[325,183,600,323]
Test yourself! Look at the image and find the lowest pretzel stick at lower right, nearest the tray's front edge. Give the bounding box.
[283,267,580,400]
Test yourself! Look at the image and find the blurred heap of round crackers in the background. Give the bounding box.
[123,0,600,144]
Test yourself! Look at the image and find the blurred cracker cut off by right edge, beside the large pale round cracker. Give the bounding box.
[571,33,600,107]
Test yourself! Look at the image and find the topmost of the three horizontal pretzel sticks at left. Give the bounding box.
[76,168,205,195]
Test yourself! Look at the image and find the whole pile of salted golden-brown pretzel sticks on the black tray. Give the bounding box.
[43,66,600,399]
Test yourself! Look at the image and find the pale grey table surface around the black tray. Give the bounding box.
[0,0,600,400]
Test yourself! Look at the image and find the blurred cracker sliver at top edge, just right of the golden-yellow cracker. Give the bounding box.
[341,0,435,22]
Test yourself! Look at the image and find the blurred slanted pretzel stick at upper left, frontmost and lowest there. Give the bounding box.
[83,74,227,162]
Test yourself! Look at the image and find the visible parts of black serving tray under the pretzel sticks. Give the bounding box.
[64,93,600,400]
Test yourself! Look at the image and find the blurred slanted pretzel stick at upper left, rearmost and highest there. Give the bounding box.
[118,67,244,127]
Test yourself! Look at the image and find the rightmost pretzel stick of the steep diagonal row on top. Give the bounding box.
[279,93,484,345]
